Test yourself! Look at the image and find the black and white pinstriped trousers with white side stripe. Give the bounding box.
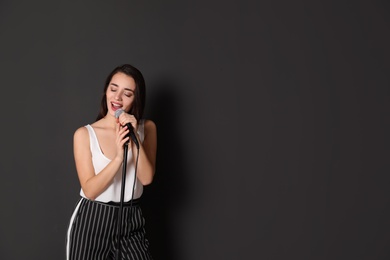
[66,198,152,260]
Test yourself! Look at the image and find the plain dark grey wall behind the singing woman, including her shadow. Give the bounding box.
[0,0,390,260]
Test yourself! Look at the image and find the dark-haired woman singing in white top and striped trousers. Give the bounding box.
[67,64,157,260]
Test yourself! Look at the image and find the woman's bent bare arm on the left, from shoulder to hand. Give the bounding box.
[73,126,132,200]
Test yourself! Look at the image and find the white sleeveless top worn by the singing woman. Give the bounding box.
[80,120,144,203]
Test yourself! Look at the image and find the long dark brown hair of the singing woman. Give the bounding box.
[96,64,146,121]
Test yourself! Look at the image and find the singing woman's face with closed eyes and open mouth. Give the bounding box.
[106,72,136,116]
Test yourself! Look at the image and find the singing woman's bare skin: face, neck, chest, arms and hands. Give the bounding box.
[73,72,157,200]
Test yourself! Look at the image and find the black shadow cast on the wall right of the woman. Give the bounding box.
[142,80,188,260]
